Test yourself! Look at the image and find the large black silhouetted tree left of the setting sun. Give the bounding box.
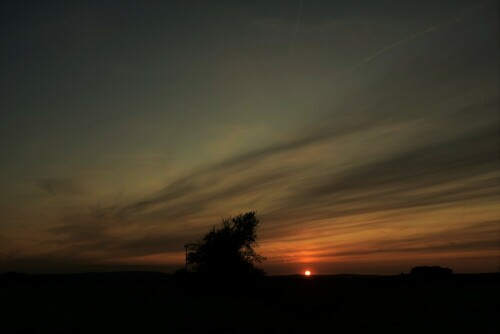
[187,211,265,278]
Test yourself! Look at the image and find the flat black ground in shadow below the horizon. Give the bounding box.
[0,272,500,333]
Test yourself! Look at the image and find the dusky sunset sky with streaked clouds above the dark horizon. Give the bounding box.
[0,0,500,274]
